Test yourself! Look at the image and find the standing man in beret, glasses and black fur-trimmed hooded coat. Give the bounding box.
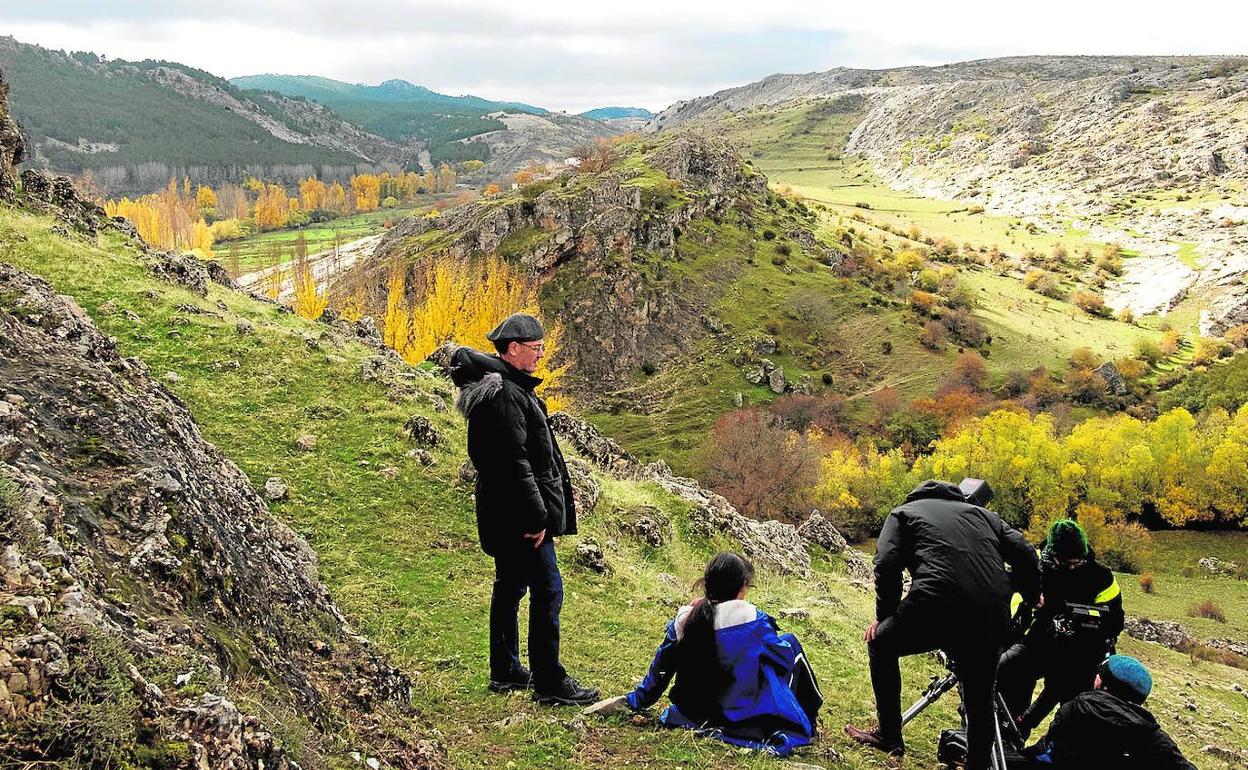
[451,313,598,705]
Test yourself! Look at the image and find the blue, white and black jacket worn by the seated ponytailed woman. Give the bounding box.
[626,603,817,756]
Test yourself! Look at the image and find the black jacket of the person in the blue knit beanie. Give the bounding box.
[1027,690,1196,770]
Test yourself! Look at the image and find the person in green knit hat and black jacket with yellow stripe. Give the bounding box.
[998,519,1124,735]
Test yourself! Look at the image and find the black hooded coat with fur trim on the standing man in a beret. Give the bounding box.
[451,348,577,555]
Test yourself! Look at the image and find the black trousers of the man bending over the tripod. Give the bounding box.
[867,612,1005,770]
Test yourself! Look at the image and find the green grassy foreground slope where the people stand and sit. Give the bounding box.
[0,192,1248,769]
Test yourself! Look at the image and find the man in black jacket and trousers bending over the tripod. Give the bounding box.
[845,480,1040,770]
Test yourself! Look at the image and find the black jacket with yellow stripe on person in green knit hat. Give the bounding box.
[1027,549,1126,654]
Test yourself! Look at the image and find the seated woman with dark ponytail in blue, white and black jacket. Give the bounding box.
[587,553,824,756]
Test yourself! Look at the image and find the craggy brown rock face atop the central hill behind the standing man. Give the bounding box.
[367,132,766,393]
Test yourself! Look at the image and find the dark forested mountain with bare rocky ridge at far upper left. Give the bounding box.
[0,37,422,193]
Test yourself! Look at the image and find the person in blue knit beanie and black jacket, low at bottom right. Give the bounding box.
[1023,655,1196,770]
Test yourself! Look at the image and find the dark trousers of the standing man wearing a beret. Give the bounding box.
[489,539,567,689]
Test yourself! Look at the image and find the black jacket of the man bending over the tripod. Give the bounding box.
[875,480,1040,628]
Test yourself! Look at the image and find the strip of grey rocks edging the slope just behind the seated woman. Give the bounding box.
[550,414,811,577]
